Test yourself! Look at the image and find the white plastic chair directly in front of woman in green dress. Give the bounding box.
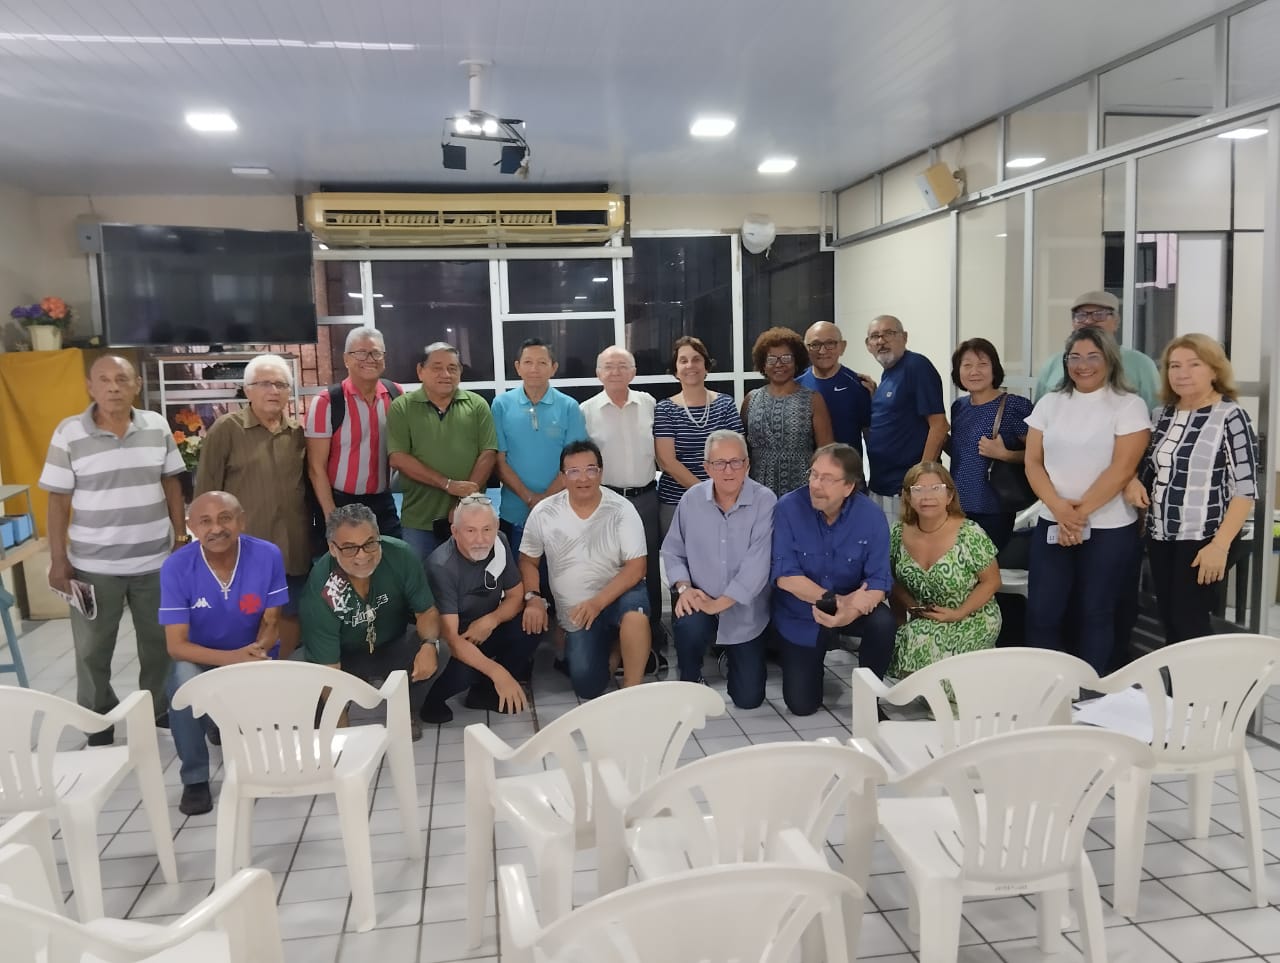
[851,647,1098,773]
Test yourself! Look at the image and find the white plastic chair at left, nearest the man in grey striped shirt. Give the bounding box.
[0,685,178,921]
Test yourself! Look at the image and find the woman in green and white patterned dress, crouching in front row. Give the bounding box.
[888,461,1000,679]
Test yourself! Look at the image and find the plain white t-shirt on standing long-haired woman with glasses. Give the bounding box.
[1027,387,1151,529]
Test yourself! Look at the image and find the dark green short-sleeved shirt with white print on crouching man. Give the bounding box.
[298,535,435,666]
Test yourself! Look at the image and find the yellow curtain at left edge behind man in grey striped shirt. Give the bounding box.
[0,348,88,535]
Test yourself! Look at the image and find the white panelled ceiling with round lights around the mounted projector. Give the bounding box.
[0,0,1254,193]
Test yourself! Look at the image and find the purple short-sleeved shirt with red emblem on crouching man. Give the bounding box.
[160,535,289,651]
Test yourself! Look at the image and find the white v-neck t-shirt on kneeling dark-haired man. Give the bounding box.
[520,487,648,631]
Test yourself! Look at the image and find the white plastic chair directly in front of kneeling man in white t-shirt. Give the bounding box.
[462,683,724,946]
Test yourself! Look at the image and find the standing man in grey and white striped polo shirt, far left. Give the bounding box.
[40,355,191,745]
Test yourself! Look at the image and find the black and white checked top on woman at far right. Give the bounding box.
[1138,398,1258,542]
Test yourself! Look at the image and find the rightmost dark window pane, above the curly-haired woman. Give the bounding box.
[742,234,834,366]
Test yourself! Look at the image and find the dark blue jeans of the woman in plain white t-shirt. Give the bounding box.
[1027,519,1142,675]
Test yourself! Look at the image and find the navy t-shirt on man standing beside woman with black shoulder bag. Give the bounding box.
[867,351,946,494]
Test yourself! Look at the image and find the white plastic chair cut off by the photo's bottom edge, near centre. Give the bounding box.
[498,830,864,963]
